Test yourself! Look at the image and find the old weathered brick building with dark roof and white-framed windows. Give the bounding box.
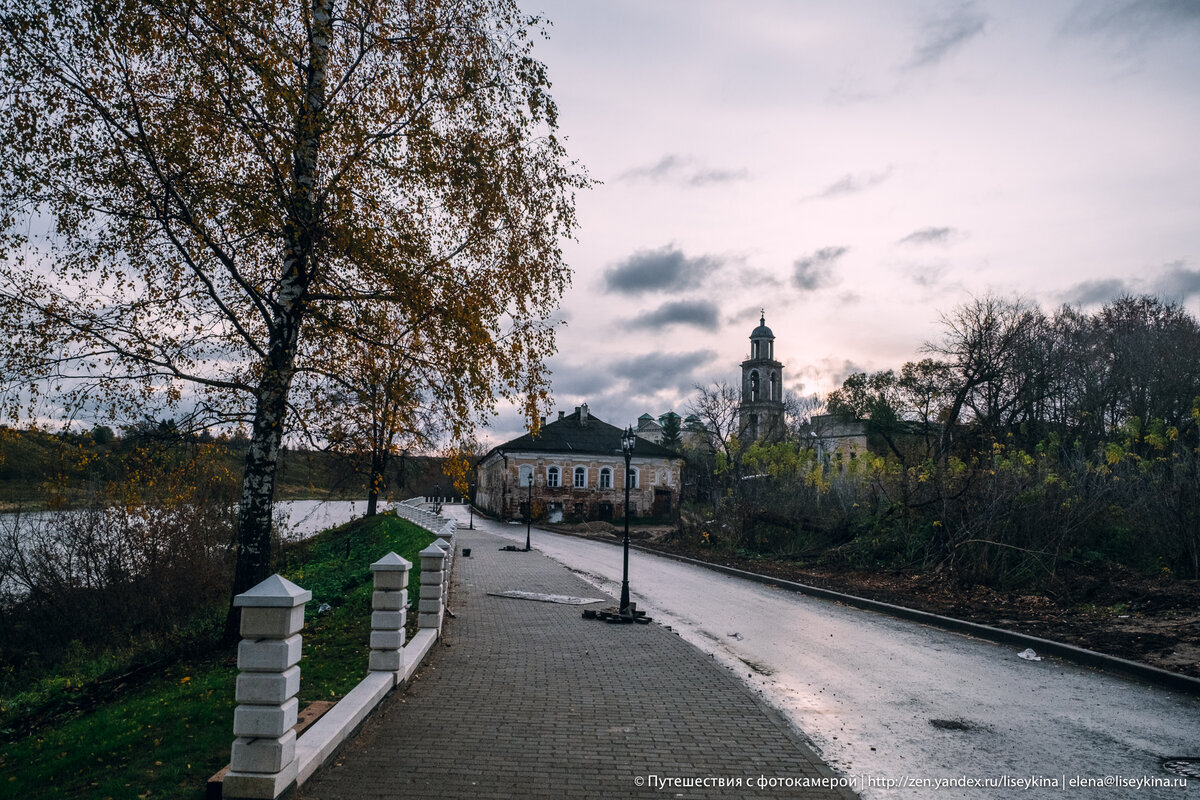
[475,403,683,522]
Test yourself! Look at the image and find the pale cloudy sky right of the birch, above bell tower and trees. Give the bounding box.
[481,0,1200,444]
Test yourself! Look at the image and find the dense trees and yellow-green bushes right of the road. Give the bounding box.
[690,296,1200,585]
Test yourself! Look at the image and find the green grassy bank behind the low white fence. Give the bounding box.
[0,516,434,800]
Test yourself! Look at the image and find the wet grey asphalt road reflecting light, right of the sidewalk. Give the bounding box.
[446,506,1200,799]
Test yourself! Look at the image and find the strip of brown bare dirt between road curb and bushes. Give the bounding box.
[553,522,1200,678]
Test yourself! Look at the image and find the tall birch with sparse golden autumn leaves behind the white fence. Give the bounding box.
[0,0,587,614]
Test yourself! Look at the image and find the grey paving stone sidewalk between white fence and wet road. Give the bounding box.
[296,529,854,800]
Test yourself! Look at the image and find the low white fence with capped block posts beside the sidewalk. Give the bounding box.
[222,499,456,800]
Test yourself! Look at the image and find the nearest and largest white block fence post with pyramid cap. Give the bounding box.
[222,575,312,800]
